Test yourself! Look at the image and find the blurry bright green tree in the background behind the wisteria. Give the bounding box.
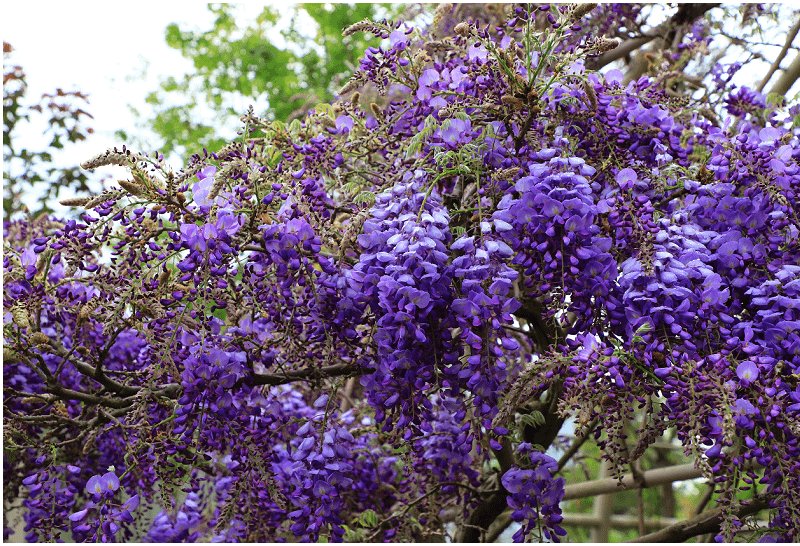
[117,4,404,162]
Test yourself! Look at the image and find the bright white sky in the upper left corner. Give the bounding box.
[0,1,276,213]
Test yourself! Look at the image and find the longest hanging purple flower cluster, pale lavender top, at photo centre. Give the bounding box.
[348,171,453,437]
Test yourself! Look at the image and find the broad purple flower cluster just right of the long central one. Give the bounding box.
[492,149,618,330]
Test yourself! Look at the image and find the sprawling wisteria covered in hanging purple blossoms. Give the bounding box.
[3,4,800,541]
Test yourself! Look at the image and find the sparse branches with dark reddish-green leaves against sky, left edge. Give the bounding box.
[3,42,92,220]
